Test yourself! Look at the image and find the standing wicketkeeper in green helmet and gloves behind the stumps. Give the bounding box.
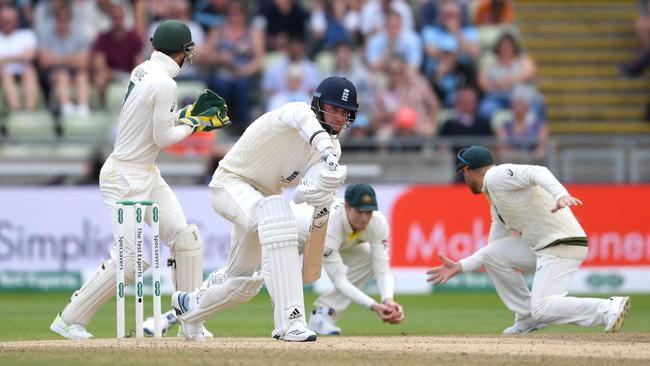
[50,20,230,339]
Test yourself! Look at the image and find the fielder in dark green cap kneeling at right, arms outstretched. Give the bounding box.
[427,146,630,334]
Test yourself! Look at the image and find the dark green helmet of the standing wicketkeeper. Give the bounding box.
[151,19,194,63]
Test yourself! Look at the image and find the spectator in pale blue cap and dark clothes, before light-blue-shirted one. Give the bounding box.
[431,38,476,108]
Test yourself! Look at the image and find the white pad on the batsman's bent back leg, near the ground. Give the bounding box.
[179,276,264,323]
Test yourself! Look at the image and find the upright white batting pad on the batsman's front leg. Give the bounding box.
[258,196,305,334]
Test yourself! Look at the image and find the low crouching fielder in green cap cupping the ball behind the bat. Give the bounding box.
[292,184,404,335]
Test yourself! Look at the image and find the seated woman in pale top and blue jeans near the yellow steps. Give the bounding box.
[478,33,543,119]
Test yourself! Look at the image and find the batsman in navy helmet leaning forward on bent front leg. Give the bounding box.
[172,77,358,341]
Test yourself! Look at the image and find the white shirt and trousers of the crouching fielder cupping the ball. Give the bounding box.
[292,198,394,317]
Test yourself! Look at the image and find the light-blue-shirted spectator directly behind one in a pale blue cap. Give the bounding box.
[422,2,481,75]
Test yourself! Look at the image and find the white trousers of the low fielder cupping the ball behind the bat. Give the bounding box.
[314,243,374,320]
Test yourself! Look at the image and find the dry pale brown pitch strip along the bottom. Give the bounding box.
[0,333,650,366]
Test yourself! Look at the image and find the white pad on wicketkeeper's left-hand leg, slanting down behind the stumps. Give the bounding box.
[61,255,149,326]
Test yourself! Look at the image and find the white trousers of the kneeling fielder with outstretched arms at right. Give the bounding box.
[483,237,608,326]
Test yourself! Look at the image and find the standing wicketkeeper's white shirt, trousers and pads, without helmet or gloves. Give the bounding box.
[61,51,203,325]
